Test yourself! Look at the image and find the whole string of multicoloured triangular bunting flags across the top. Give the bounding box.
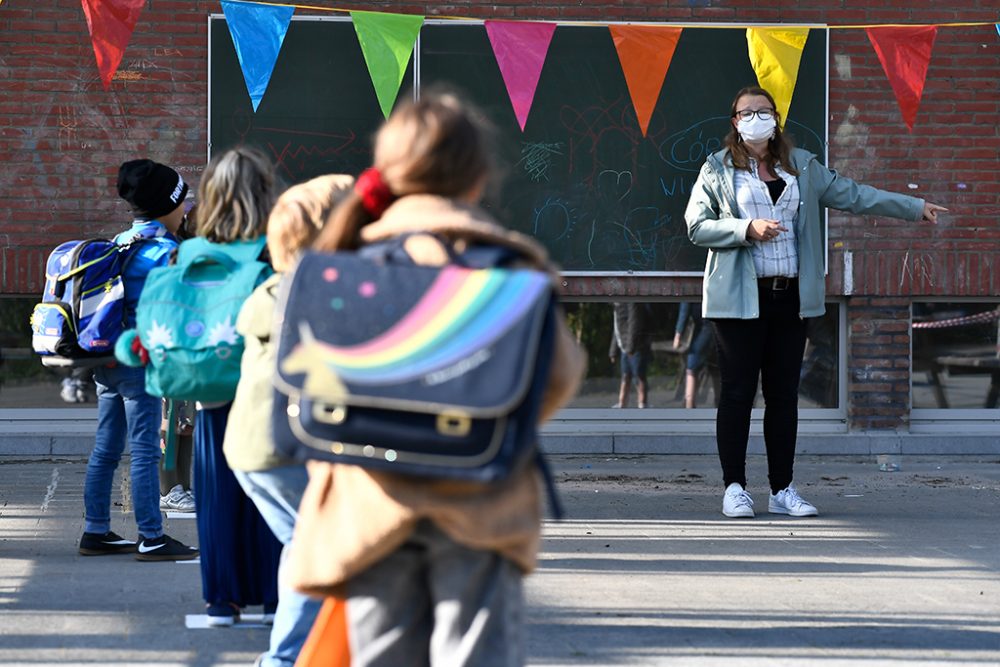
[76,0,1000,136]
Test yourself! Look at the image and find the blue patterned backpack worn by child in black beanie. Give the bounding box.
[31,239,141,366]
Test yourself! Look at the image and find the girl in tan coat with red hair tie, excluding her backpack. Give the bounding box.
[289,95,584,667]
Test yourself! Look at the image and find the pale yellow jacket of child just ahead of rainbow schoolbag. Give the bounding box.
[222,273,295,472]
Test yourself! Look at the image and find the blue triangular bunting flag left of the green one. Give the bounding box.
[222,0,295,113]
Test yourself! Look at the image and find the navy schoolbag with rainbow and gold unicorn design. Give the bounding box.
[273,241,557,500]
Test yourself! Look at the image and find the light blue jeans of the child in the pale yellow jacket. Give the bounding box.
[233,465,323,667]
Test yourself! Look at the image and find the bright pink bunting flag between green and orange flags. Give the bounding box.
[486,21,556,132]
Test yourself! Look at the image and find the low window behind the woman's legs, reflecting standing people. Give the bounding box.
[564,301,840,409]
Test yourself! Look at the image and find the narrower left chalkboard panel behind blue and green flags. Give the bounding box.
[209,16,413,184]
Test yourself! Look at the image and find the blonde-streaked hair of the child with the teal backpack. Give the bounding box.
[195,146,280,243]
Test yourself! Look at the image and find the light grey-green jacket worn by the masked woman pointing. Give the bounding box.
[684,148,924,320]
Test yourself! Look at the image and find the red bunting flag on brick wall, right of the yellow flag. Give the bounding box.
[865,26,937,132]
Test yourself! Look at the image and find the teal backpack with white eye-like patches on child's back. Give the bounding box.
[115,238,274,402]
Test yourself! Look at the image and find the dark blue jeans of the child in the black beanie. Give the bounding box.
[83,365,163,538]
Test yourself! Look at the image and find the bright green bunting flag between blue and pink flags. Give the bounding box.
[351,12,424,118]
